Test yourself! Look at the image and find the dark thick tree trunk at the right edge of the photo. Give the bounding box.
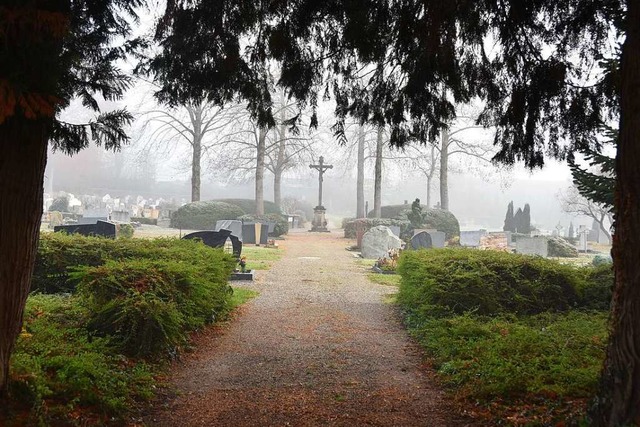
[590,1,640,426]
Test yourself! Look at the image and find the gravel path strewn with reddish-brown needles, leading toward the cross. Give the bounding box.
[145,231,467,427]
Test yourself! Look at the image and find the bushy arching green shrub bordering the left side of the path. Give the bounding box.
[71,258,234,357]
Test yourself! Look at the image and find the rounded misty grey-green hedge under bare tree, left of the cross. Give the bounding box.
[171,201,246,230]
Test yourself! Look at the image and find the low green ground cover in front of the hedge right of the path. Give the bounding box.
[409,311,607,401]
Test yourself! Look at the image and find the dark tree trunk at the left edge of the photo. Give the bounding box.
[0,116,50,397]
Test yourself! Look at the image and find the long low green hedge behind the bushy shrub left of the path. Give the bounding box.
[31,233,231,294]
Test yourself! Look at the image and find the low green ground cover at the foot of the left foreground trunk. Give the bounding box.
[10,295,154,425]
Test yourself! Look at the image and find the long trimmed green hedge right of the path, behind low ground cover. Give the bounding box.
[397,249,612,316]
